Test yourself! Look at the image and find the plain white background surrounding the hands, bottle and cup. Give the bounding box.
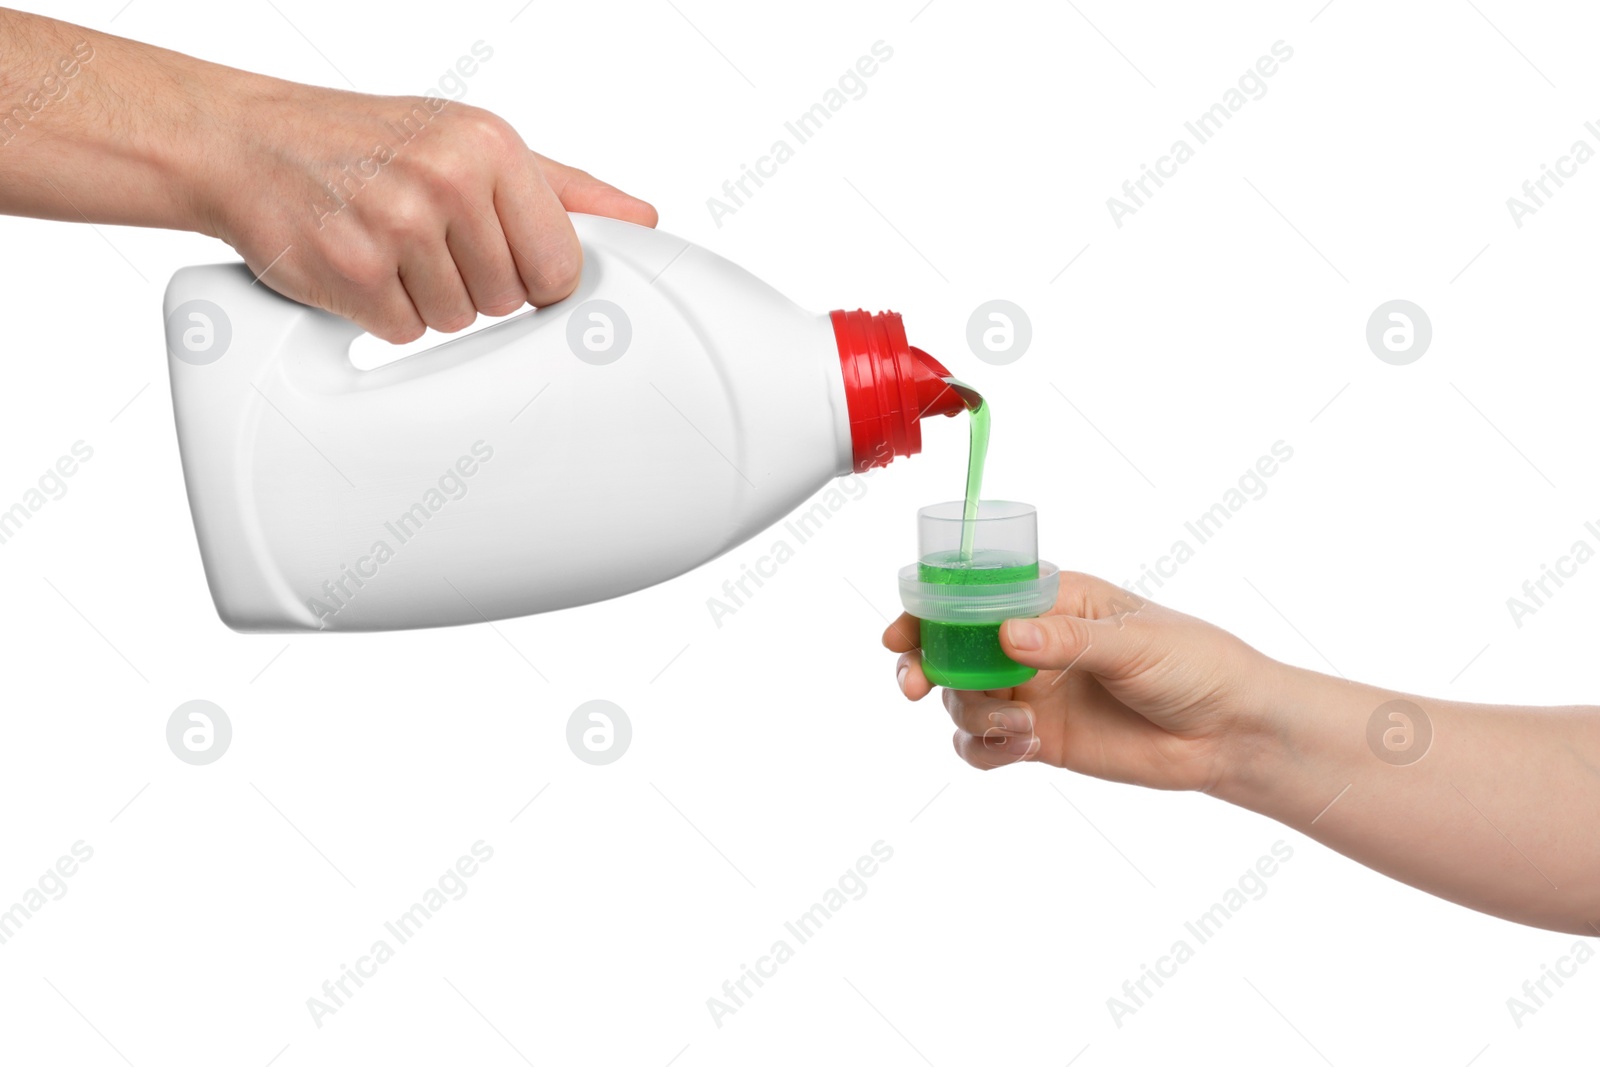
[0,0,1600,1067]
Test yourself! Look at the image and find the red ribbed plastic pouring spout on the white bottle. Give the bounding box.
[830,310,966,472]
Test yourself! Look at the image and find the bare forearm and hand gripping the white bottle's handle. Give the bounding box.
[0,8,656,342]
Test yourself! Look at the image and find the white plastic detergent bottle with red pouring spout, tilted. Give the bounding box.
[165,216,963,630]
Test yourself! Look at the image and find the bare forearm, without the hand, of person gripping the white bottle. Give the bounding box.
[0,8,246,230]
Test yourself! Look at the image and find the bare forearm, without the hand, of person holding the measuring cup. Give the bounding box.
[1214,667,1600,934]
